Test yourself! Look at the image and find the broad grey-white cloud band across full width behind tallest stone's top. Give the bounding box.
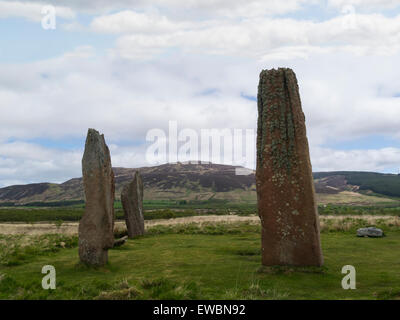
[0,48,400,145]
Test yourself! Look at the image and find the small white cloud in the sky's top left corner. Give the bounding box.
[0,1,75,22]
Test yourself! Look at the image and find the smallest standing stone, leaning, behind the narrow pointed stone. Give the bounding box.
[121,171,144,239]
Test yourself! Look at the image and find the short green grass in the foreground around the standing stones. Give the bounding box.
[0,223,400,299]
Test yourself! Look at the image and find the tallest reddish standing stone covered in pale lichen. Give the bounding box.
[256,68,323,266]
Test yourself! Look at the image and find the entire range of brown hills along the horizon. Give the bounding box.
[0,163,400,205]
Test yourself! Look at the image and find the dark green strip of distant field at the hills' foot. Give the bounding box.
[0,200,400,223]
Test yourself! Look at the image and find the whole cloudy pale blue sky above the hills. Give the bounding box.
[0,0,400,187]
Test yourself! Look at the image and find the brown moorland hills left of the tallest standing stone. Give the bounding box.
[0,163,255,203]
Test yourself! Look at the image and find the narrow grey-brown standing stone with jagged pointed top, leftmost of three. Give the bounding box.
[79,129,115,266]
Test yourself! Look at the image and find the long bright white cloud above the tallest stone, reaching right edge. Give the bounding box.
[105,12,400,60]
